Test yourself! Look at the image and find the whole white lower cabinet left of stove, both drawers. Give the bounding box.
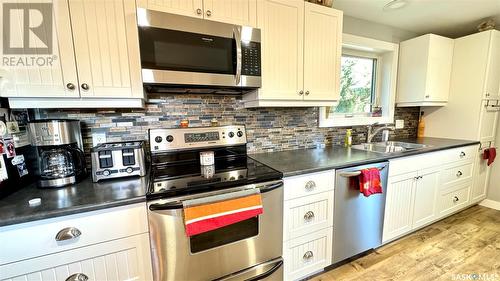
[0,203,153,281]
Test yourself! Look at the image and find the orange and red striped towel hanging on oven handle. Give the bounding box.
[182,188,264,237]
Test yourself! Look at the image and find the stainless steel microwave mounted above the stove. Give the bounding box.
[137,8,261,90]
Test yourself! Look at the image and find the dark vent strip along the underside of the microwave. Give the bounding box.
[144,84,256,95]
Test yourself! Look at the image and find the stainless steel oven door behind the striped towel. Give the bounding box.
[148,181,283,281]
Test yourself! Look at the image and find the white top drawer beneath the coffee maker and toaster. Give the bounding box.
[0,203,148,265]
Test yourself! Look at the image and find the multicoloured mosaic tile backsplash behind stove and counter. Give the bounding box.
[35,94,419,153]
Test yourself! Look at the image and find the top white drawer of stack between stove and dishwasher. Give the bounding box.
[284,170,335,200]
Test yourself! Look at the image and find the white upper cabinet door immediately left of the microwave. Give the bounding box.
[69,0,143,98]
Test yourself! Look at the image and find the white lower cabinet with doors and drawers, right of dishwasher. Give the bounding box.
[382,145,477,243]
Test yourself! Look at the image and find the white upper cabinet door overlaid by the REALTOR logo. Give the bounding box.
[0,1,79,97]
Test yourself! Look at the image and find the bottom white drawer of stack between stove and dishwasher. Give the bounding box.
[284,227,333,280]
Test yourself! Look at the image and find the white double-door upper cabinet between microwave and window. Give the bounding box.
[243,0,342,107]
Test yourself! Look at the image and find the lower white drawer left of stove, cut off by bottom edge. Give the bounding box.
[0,233,153,281]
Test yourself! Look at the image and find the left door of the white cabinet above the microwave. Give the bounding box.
[137,0,203,18]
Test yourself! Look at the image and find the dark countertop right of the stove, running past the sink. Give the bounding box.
[250,138,479,177]
